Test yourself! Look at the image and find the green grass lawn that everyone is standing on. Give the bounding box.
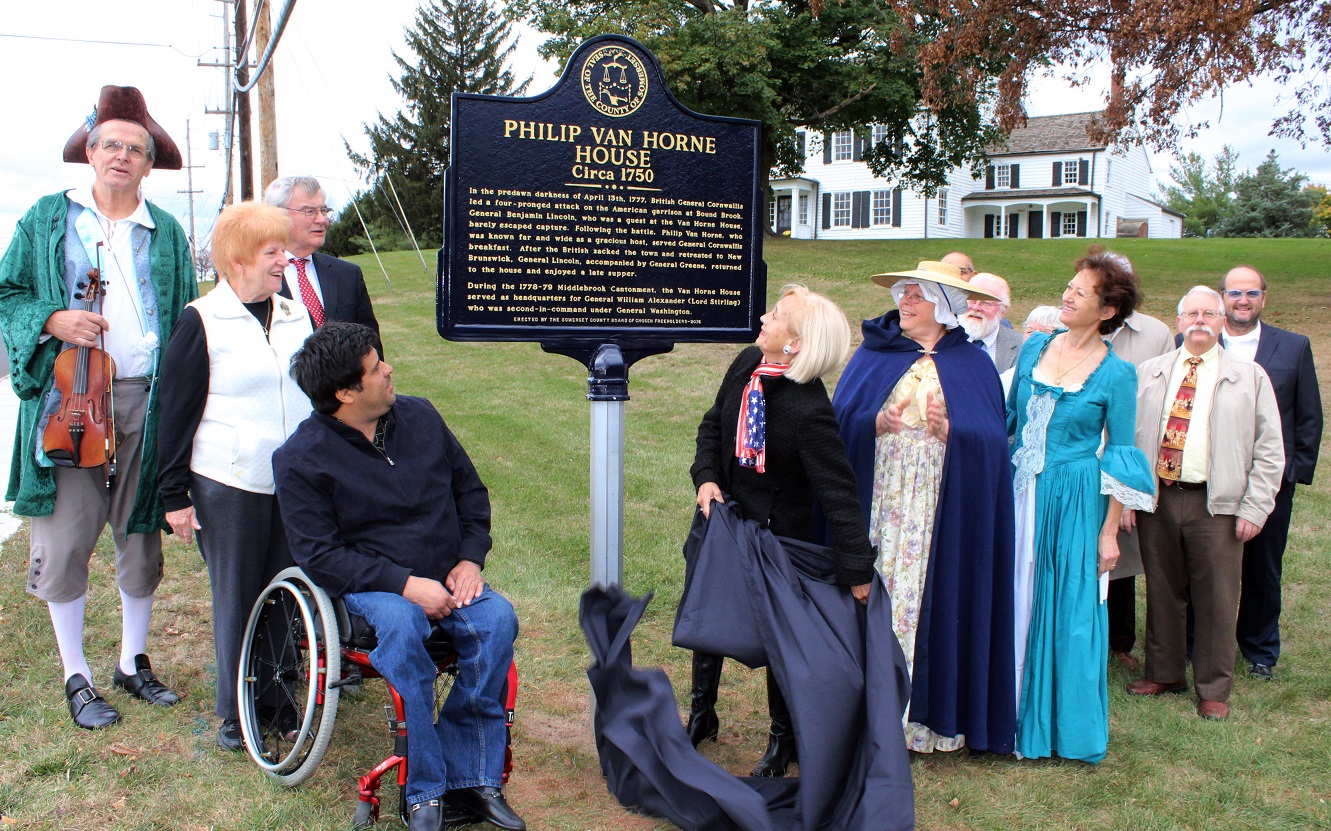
[0,240,1331,831]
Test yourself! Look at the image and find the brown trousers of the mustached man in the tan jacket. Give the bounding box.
[1137,482,1243,702]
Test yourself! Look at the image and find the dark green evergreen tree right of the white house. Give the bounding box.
[1221,150,1318,237]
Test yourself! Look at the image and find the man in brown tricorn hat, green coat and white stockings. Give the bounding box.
[0,87,198,730]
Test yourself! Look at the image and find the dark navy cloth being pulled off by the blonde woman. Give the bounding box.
[582,503,914,831]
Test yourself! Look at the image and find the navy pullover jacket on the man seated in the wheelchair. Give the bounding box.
[273,396,491,597]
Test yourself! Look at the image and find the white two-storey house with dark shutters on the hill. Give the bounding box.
[768,112,1183,240]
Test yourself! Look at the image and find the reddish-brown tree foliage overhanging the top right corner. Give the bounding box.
[878,0,1331,148]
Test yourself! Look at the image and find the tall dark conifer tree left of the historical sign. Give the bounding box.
[329,0,530,253]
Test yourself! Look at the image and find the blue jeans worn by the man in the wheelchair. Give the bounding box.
[343,586,518,804]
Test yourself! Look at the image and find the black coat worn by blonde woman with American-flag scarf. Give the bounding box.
[689,346,874,586]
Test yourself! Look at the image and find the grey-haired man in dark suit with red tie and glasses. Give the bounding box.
[264,176,383,356]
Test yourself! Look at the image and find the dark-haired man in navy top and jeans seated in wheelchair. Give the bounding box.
[273,322,526,831]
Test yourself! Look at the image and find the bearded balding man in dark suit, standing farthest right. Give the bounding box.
[1221,265,1322,681]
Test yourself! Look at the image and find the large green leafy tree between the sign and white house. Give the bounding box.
[508,0,1001,194]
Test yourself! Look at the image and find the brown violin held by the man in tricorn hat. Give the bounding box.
[41,242,116,487]
